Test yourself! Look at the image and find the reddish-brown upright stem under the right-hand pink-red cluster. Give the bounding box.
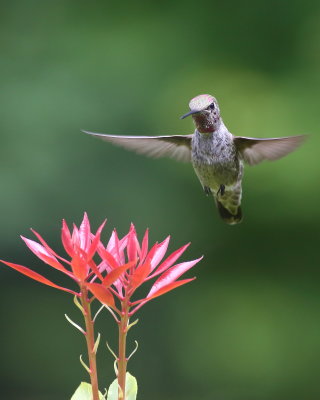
[118,298,129,400]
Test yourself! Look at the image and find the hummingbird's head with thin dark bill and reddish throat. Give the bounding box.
[180,94,221,133]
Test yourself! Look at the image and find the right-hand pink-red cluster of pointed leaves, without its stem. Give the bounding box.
[86,224,202,316]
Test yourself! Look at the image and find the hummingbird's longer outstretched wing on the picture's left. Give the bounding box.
[83,131,192,161]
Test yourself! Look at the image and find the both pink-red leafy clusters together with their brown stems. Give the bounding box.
[0,214,201,400]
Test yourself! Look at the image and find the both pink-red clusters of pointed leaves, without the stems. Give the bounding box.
[2,213,201,315]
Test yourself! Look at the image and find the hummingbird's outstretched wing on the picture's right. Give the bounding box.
[233,135,307,165]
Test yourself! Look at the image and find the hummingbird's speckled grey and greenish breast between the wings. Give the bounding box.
[191,126,243,193]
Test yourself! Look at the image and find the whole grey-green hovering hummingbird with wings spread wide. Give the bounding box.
[83,94,305,225]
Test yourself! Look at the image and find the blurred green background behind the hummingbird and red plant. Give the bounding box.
[0,0,320,400]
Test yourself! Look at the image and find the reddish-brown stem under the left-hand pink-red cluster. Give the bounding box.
[81,286,99,400]
